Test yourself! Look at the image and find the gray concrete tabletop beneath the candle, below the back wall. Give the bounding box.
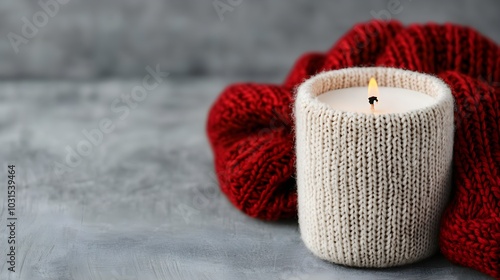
[0,78,488,280]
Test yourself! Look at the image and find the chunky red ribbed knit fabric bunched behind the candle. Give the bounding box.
[207,21,500,278]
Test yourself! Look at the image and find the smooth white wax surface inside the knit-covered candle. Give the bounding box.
[317,87,435,114]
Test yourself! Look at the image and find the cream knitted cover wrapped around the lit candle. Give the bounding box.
[295,67,453,267]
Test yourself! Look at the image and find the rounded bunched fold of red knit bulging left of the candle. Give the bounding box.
[208,84,297,220]
